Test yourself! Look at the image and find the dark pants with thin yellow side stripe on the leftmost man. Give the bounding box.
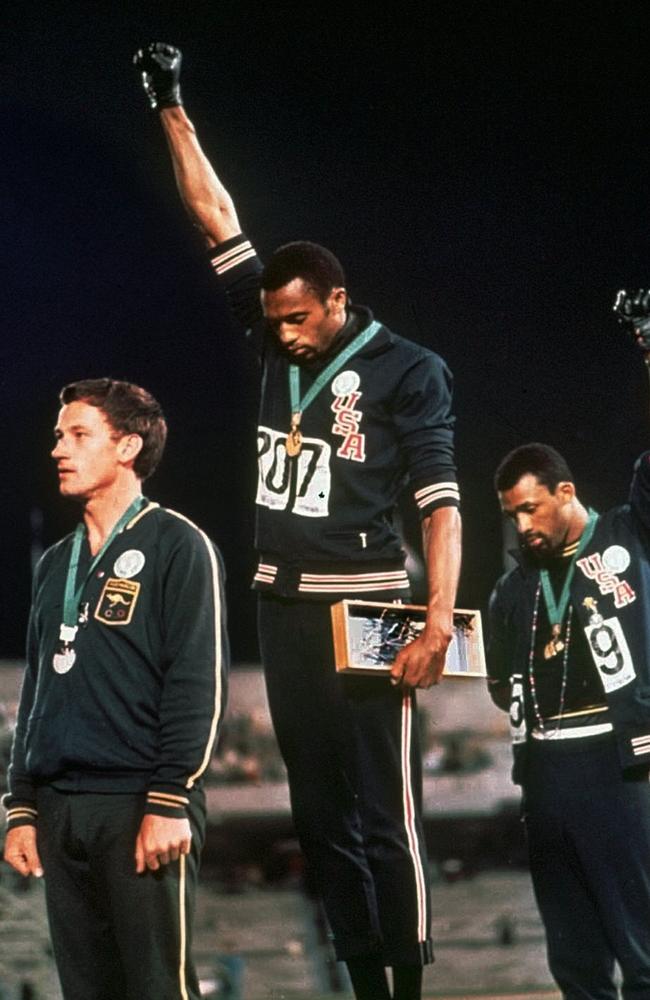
[38,787,205,1000]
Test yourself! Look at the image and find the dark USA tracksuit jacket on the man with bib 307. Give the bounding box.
[212,235,459,600]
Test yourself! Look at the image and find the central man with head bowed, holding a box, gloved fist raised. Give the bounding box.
[136,43,460,1000]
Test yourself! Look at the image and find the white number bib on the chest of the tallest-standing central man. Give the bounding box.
[255,427,332,517]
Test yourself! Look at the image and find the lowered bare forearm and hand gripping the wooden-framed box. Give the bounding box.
[391,507,461,688]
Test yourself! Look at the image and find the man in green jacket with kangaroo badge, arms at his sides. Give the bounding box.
[4,379,227,1000]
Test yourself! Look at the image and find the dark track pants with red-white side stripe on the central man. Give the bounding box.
[259,594,433,965]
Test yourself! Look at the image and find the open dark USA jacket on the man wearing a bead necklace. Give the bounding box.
[487,452,650,782]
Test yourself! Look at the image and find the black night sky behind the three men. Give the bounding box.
[0,0,650,659]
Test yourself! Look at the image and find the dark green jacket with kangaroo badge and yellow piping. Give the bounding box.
[5,502,228,827]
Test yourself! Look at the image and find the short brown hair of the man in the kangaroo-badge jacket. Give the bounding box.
[59,378,167,480]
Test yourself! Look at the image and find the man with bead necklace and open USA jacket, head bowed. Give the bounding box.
[488,292,650,1000]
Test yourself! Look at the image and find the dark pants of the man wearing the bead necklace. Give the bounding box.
[524,734,650,1000]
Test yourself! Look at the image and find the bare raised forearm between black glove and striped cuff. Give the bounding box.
[160,106,241,246]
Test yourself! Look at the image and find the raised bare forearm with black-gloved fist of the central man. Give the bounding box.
[134,42,241,246]
